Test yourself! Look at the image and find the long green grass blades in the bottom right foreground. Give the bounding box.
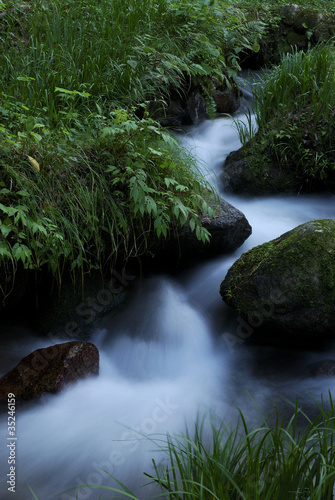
[47,394,335,500]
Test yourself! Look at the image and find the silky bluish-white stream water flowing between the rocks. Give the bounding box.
[0,99,335,500]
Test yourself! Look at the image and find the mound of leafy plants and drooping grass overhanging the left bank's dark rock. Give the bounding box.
[0,109,217,292]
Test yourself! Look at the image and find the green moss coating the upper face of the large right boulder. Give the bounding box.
[221,220,335,329]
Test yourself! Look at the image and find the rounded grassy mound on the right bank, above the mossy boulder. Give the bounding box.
[234,42,335,191]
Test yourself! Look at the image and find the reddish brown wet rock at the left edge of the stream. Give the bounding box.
[0,341,99,401]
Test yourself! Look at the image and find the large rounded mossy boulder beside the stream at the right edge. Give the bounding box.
[220,219,335,339]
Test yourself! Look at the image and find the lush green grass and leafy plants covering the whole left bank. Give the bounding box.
[0,0,272,296]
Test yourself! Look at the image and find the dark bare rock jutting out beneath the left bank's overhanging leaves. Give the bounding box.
[150,200,252,269]
